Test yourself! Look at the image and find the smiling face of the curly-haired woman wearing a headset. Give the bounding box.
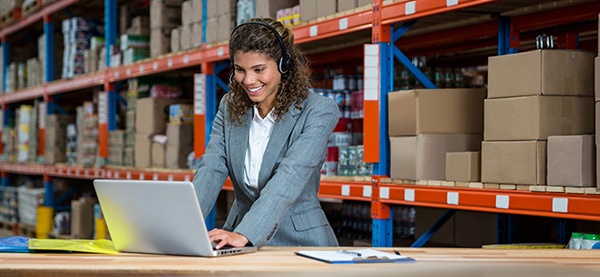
[233,51,281,113]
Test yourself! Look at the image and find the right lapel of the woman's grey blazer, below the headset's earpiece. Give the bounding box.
[258,104,301,191]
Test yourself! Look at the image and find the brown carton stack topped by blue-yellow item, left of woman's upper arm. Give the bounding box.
[165,104,194,168]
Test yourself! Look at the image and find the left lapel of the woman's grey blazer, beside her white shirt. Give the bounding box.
[229,108,253,187]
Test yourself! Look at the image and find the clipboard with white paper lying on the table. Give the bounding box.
[296,248,415,263]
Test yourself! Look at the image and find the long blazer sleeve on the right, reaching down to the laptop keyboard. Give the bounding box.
[234,95,339,247]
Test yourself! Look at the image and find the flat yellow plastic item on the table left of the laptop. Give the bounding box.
[29,239,119,254]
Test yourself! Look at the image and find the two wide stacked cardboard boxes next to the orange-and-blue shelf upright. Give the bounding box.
[389,89,486,180]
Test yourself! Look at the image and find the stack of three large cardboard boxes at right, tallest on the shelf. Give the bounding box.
[481,50,594,185]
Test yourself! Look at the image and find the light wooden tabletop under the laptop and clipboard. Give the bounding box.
[0,247,600,277]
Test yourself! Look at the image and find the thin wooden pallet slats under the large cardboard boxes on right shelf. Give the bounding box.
[381,178,600,195]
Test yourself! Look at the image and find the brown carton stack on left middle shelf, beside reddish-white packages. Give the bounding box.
[44,114,75,164]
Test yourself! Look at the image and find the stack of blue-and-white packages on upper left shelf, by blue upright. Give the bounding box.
[62,17,104,79]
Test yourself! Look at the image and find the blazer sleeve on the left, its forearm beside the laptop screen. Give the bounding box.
[192,97,229,219]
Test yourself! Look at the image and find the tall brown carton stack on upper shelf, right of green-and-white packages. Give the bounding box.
[150,0,183,57]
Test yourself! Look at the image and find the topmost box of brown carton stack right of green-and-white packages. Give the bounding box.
[150,0,183,28]
